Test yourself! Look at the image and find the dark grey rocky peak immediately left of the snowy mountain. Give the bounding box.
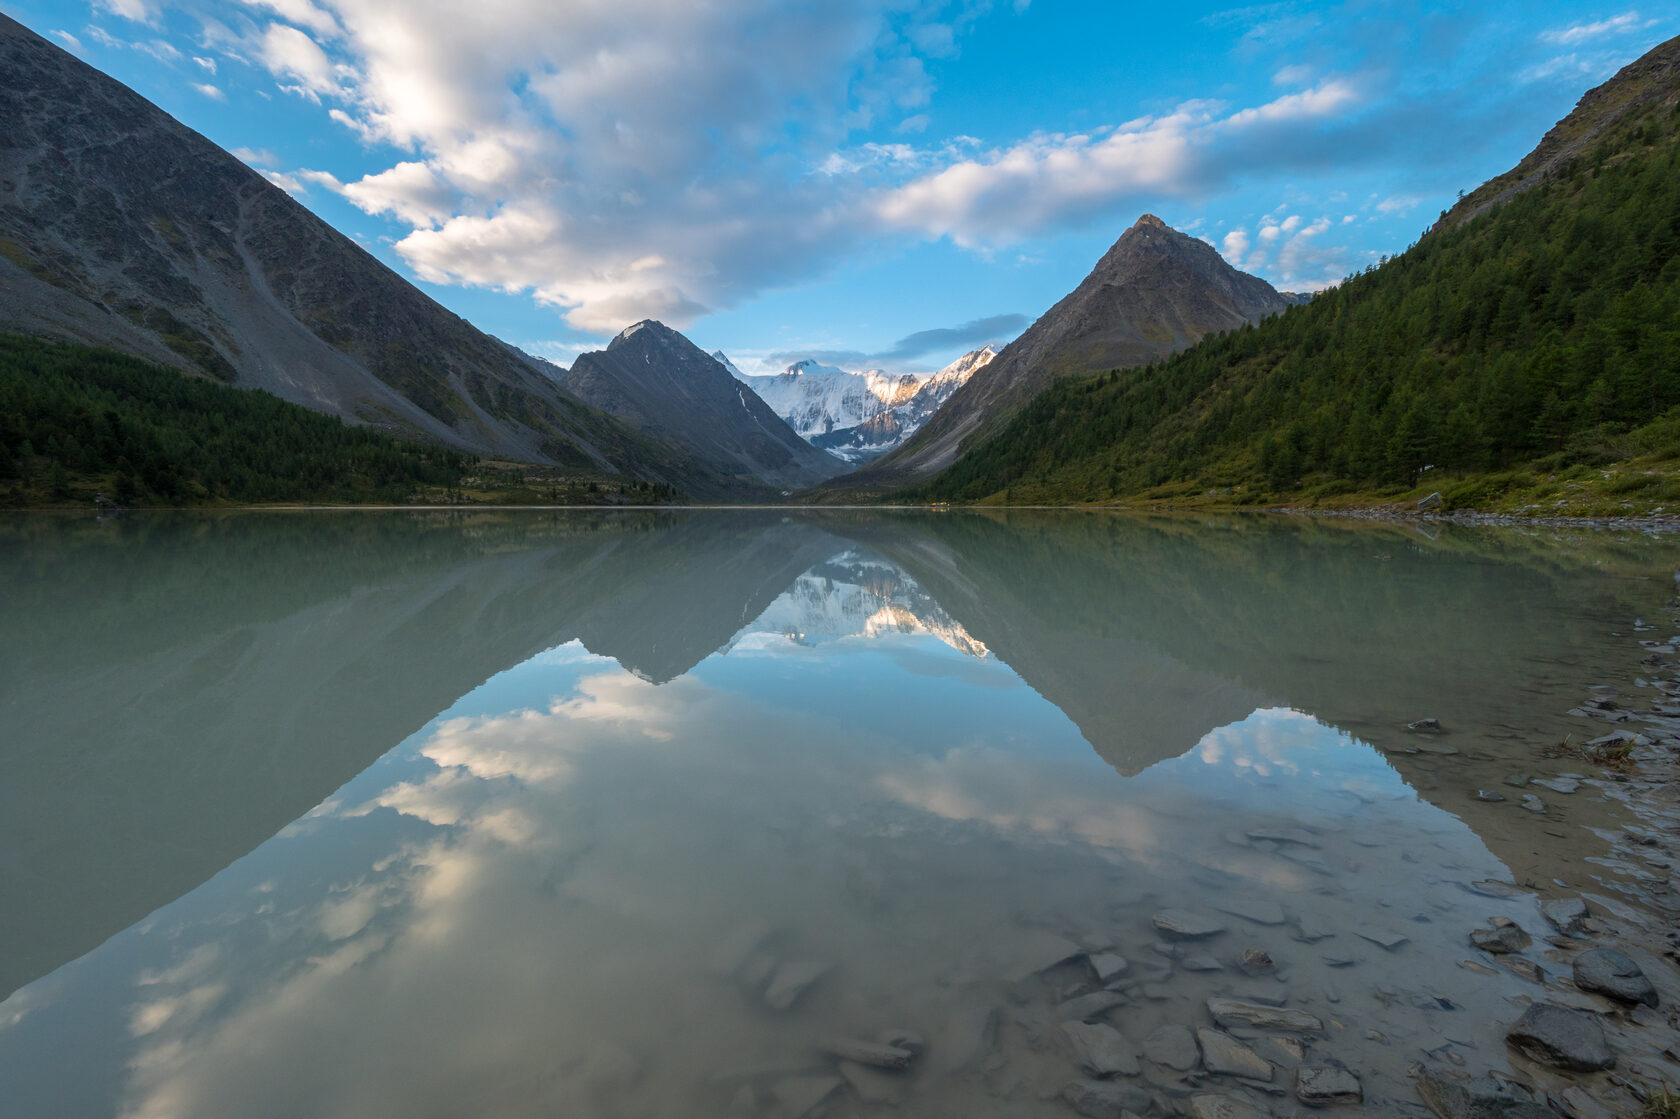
[559,319,843,489]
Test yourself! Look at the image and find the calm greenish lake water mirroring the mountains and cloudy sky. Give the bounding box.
[0,511,1680,1119]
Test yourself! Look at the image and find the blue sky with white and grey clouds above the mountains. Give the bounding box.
[0,0,1680,373]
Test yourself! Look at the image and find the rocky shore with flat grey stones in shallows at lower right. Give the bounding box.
[716,571,1680,1119]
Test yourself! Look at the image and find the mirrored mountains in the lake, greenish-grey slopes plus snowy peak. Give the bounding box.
[0,511,1665,993]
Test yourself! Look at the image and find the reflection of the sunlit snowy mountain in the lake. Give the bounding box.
[732,549,988,657]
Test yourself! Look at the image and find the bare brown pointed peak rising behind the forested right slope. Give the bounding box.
[845,213,1290,489]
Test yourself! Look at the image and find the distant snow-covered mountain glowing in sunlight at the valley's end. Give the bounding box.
[731,346,996,462]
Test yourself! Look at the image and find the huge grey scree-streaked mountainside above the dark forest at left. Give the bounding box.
[0,15,682,482]
